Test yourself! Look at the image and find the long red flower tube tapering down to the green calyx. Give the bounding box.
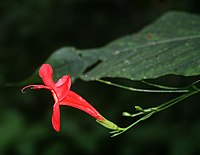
[59,90,104,120]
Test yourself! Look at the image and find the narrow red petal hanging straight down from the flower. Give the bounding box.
[52,103,60,132]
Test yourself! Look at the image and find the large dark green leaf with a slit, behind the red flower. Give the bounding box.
[21,12,200,83]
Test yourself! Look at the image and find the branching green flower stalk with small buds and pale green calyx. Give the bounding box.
[97,79,200,137]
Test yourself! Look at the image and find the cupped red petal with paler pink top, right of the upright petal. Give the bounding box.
[55,75,71,101]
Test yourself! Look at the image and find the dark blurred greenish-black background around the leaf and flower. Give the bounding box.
[0,0,200,155]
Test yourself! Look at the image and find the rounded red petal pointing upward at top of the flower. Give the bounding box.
[39,64,55,89]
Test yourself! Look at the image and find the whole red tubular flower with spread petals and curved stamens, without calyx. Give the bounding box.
[22,64,104,132]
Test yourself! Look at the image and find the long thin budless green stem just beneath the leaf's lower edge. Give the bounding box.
[96,79,190,93]
